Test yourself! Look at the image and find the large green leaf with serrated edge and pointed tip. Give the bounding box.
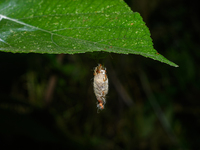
[0,0,177,67]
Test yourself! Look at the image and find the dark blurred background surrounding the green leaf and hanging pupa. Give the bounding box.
[0,0,200,150]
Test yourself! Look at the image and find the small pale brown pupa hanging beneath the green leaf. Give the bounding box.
[93,64,108,110]
